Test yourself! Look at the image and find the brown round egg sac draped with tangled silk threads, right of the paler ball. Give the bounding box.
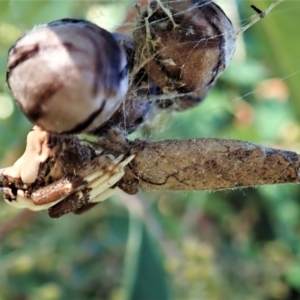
[134,0,235,108]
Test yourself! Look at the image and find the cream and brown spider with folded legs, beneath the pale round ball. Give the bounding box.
[0,126,134,217]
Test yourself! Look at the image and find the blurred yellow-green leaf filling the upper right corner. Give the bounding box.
[247,0,300,118]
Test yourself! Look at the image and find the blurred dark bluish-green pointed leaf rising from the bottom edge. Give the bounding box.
[123,213,170,300]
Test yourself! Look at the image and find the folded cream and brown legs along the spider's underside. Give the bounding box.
[0,155,134,211]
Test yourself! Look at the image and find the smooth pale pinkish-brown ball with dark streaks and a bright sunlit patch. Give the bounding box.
[7,19,128,133]
